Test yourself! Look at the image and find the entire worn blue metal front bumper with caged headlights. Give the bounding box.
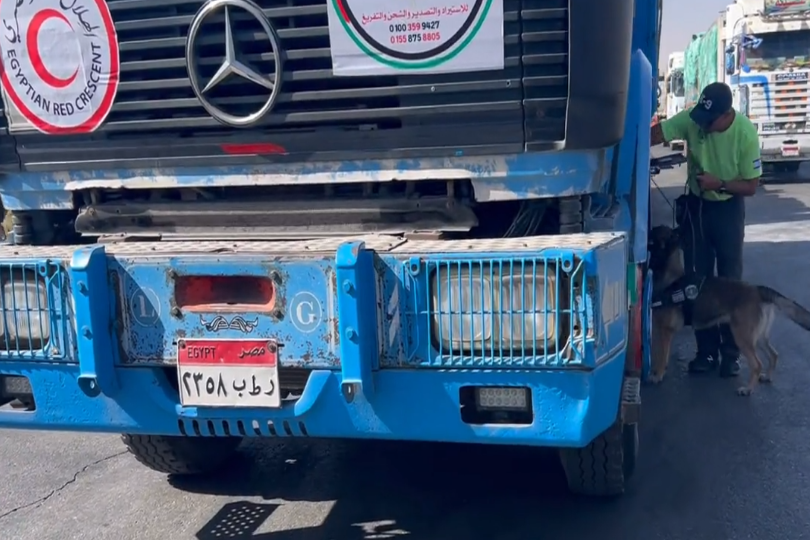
[0,234,628,446]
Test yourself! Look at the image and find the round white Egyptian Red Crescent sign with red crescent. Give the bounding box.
[0,0,120,135]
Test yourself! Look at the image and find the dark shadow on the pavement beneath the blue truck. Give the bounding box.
[171,441,619,540]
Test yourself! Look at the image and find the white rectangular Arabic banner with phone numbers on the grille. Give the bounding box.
[328,0,504,76]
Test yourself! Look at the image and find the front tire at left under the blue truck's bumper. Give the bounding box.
[121,433,242,476]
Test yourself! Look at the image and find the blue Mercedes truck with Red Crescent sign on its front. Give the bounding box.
[0,0,661,496]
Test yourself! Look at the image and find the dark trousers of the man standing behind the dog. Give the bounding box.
[681,194,745,371]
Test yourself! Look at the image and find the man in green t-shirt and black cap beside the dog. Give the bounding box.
[651,82,762,377]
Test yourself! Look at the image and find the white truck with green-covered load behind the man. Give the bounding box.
[684,0,810,171]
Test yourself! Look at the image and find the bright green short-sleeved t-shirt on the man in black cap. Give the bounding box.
[661,109,762,201]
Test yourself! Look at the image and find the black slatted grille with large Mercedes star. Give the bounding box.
[15,0,569,171]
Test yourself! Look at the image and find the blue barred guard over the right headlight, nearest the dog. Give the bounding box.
[420,257,592,368]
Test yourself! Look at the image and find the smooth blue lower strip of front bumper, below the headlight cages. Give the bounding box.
[0,353,624,447]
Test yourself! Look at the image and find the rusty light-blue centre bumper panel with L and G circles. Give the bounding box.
[110,254,340,368]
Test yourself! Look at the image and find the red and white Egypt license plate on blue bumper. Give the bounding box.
[177,339,281,407]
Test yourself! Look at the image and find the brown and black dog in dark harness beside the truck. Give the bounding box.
[649,225,810,396]
